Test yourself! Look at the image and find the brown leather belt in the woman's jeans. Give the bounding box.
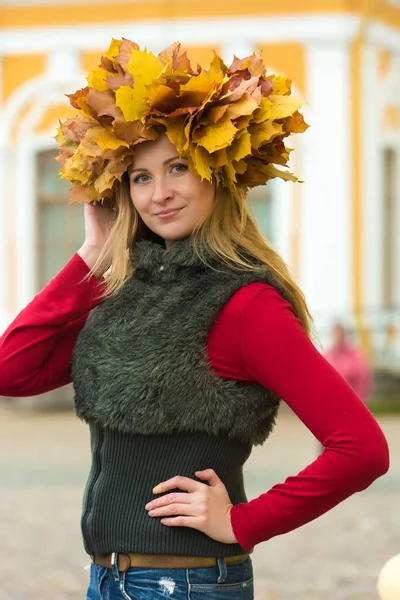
[92,552,248,573]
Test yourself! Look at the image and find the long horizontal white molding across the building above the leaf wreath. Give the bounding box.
[0,13,360,55]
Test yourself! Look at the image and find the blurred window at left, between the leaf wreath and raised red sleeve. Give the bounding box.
[36,150,85,291]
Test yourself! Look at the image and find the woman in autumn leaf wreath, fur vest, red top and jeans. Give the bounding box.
[0,40,388,600]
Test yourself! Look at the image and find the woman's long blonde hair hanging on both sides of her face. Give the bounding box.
[92,176,312,337]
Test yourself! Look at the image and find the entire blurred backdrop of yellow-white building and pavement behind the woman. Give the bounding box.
[0,0,400,600]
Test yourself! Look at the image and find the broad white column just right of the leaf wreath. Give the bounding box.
[300,40,353,333]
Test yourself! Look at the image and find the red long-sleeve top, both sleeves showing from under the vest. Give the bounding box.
[0,254,389,549]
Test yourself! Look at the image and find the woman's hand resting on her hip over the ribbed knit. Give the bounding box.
[145,469,237,544]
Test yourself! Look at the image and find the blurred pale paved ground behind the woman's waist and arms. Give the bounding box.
[0,404,400,600]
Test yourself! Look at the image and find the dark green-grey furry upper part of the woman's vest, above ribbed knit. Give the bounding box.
[72,239,282,444]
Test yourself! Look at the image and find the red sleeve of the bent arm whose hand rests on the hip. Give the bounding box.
[208,283,389,549]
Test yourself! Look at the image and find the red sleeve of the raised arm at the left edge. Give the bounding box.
[0,254,104,397]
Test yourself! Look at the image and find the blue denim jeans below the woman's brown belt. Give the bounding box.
[86,558,254,600]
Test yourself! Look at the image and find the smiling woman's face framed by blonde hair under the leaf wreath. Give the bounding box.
[129,135,215,246]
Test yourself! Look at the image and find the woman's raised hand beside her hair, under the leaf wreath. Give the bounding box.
[78,200,117,270]
